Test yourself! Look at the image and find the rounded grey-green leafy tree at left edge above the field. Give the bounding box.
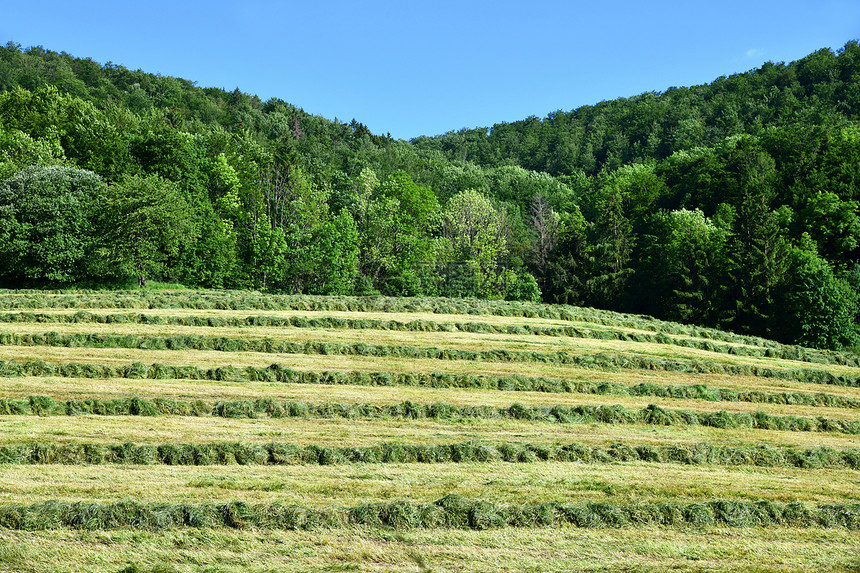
[0,166,104,286]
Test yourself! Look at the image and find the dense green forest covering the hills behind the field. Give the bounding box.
[0,41,860,349]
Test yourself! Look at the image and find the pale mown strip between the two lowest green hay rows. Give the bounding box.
[0,462,860,507]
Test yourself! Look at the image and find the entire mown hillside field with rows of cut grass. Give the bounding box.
[0,291,860,572]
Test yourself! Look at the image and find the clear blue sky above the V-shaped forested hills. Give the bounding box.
[0,0,860,139]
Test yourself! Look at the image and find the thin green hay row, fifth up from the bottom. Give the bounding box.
[0,332,860,387]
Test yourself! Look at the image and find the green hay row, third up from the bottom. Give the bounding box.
[0,396,860,434]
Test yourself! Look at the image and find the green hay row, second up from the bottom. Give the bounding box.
[0,441,860,470]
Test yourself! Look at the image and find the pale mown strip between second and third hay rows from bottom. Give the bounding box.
[0,415,858,449]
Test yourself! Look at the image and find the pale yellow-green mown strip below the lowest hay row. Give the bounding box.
[0,527,860,573]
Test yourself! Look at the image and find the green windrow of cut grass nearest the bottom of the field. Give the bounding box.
[0,495,860,531]
